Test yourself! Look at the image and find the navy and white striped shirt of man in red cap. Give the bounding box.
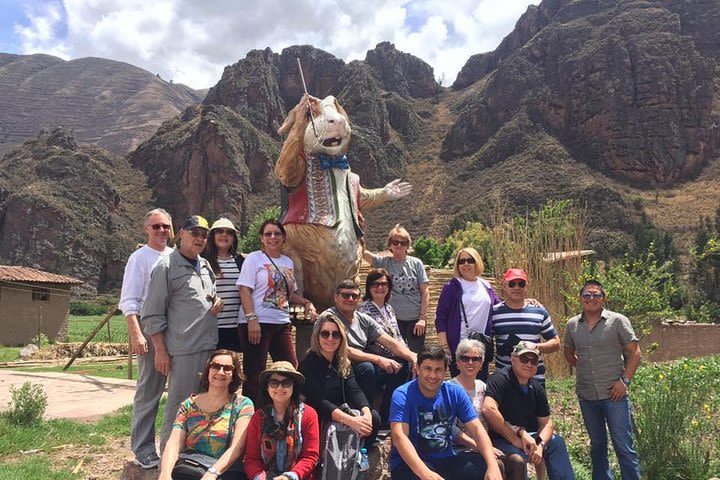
[492,302,557,381]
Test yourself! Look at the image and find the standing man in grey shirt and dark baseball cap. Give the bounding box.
[141,215,223,452]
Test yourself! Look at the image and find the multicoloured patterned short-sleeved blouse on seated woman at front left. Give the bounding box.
[173,394,255,458]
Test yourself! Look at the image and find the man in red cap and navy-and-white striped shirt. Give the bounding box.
[492,268,560,384]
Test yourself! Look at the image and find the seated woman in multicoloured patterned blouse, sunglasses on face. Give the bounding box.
[158,350,254,480]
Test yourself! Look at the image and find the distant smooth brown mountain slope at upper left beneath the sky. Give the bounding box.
[0,53,203,155]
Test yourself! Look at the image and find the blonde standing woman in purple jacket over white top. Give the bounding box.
[435,247,500,381]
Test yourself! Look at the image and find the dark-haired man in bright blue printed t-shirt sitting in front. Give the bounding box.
[390,345,502,480]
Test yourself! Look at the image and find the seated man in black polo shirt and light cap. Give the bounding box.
[482,341,575,480]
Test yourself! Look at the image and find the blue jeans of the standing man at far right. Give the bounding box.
[578,395,640,480]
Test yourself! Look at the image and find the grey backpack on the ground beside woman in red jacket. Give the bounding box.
[317,410,362,480]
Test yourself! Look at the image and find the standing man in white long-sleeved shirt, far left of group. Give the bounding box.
[119,208,172,469]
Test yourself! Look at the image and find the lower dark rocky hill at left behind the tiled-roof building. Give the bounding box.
[0,128,151,293]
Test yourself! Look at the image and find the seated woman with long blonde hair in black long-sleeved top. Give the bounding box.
[300,315,380,446]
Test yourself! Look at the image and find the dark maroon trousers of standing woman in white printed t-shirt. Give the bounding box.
[238,323,297,407]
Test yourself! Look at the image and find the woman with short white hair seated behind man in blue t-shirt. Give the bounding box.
[450,338,525,480]
